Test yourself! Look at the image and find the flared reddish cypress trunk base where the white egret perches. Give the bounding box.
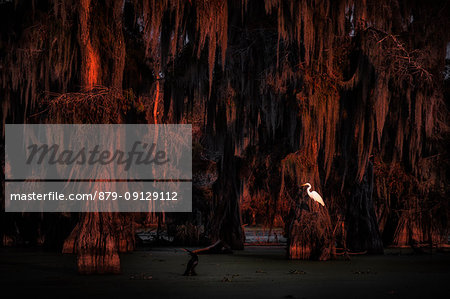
[279,152,334,260]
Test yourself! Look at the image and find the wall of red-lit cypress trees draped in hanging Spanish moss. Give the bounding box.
[0,0,450,273]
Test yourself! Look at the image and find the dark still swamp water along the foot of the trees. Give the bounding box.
[0,247,450,299]
